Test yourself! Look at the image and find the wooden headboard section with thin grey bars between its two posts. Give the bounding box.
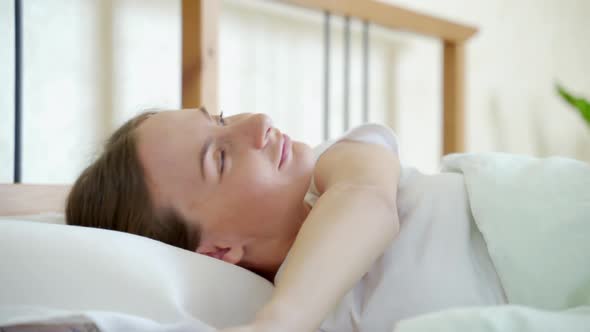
[182,0,477,155]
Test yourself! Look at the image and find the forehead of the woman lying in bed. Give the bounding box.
[137,111,207,207]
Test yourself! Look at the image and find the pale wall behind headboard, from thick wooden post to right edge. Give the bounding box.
[221,0,590,171]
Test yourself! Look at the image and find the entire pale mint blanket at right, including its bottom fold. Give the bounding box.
[396,153,590,332]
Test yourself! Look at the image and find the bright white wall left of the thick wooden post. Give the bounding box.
[0,0,180,183]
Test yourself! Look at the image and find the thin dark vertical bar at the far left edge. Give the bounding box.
[14,0,22,183]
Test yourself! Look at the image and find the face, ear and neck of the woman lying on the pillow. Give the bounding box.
[138,109,313,270]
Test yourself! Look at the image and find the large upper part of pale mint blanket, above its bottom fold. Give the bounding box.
[444,153,590,309]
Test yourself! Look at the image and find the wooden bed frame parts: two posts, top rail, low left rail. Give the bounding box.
[0,0,477,215]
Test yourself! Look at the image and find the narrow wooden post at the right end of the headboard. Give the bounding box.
[442,41,465,155]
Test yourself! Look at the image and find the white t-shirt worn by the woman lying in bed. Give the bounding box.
[277,124,506,332]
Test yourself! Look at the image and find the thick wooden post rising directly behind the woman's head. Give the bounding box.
[182,0,219,113]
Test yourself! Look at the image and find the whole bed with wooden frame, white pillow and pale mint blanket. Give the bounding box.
[0,0,590,332]
